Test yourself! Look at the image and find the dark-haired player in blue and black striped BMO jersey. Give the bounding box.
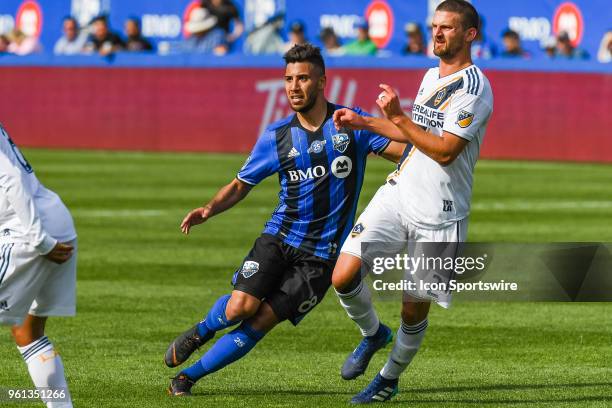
[165,44,405,395]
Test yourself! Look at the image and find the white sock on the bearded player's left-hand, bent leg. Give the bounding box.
[336,281,380,336]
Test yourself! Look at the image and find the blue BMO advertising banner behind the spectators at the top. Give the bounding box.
[0,0,612,58]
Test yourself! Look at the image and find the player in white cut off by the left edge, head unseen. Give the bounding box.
[0,125,77,408]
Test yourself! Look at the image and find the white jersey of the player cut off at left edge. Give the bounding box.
[0,125,76,254]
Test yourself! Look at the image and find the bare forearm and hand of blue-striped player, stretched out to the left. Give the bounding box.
[181,179,252,234]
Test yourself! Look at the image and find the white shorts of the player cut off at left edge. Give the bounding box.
[0,239,77,325]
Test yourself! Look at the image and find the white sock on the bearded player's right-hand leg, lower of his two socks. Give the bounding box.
[380,319,427,380]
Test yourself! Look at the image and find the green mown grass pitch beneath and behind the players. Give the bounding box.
[0,149,612,407]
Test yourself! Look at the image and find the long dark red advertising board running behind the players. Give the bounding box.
[0,67,612,162]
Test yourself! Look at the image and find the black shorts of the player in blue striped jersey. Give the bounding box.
[232,234,336,325]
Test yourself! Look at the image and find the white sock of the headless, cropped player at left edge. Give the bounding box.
[17,336,72,408]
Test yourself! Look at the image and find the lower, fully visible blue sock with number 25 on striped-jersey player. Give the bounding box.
[182,323,265,381]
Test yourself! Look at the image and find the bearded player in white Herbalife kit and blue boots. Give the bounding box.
[332,0,493,403]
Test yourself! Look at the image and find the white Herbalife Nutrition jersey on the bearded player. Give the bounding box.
[392,65,493,229]
